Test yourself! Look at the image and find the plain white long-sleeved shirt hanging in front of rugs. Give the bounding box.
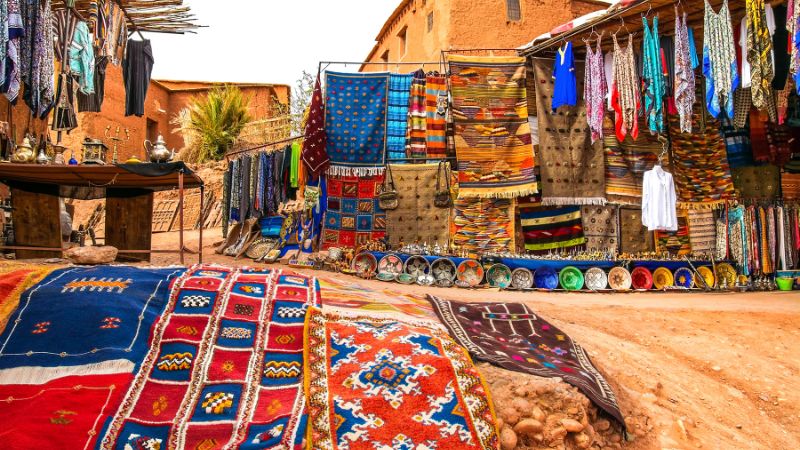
[642,165,678,231]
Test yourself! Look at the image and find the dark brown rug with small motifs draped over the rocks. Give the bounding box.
[428,295,625,429]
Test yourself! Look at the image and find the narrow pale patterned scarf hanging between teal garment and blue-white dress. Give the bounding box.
[674,6,695,133]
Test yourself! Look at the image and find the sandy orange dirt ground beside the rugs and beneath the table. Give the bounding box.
[98,229,800,449]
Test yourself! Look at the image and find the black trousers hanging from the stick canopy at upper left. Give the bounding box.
[122,39,154,117]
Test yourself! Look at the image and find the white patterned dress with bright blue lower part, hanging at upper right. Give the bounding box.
[703,0,739,118]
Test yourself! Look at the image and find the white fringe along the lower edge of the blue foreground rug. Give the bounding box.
[0,359,135,384]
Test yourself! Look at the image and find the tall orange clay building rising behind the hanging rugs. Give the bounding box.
[361,0,609,72]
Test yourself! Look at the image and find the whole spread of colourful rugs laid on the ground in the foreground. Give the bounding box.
[0,265,624,450]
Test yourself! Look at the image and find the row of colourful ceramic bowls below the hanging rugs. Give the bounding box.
[352,252,736,291]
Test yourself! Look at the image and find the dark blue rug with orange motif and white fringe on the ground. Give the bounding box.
[0,266,183,384]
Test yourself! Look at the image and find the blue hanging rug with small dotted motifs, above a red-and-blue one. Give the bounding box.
[325,72,389,176]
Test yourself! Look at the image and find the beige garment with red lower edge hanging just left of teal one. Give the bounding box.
[611,35,640,141]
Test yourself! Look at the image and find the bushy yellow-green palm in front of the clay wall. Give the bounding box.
[174,85,252,163]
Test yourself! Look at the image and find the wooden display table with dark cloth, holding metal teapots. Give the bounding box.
[0,162,204,264]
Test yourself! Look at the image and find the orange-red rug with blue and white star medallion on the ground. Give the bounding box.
[305,308,499,450]
